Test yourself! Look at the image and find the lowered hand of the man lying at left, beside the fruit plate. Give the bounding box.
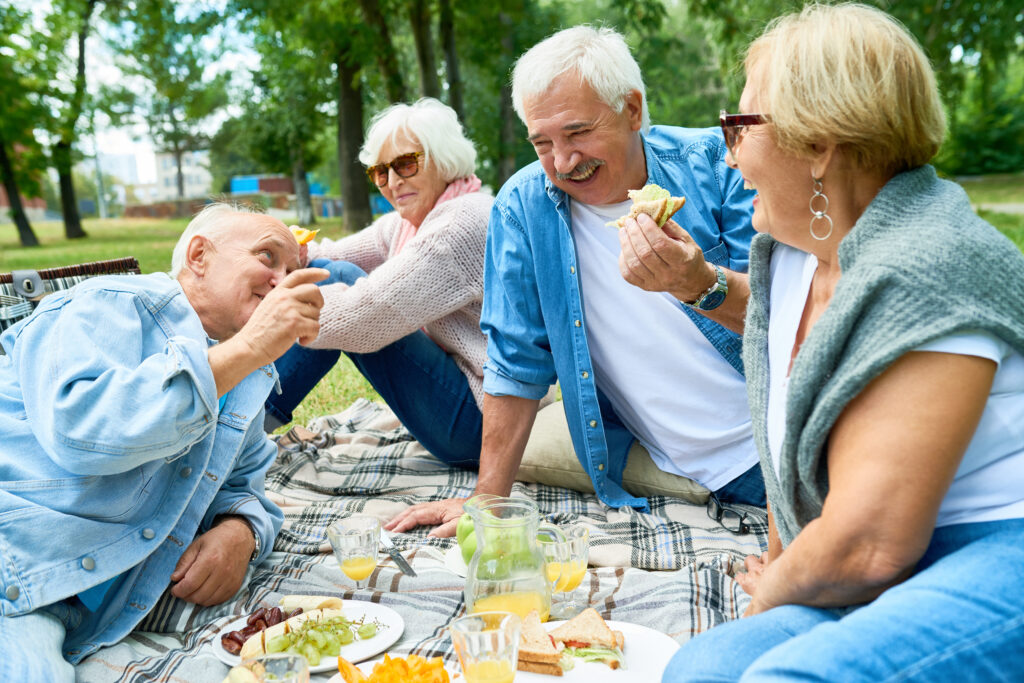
[171,517,255,605]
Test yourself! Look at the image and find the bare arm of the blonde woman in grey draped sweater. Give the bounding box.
[748,352,995,614]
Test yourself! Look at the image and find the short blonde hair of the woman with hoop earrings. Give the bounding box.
[744,3,946,174]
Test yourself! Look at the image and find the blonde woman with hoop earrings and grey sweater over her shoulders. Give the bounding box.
[663,4,1024,683]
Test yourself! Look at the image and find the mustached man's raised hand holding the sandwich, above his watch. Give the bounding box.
[618,213,715,301]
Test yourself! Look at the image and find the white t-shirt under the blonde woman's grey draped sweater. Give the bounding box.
[767,245,1024,526]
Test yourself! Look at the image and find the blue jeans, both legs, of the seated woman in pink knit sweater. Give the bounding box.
[266,259,483,468]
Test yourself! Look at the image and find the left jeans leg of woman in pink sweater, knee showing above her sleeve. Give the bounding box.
[265,259,367,424]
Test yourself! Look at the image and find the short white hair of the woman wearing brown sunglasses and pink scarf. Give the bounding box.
[359,97,476,182]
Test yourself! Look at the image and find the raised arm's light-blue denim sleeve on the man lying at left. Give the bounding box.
[16,290,217,475]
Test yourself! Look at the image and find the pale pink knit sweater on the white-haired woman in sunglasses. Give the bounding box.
[308,191,494,407]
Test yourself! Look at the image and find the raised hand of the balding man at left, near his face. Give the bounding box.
[236,268,330,367]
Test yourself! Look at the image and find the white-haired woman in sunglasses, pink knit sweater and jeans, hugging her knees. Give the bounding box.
[266,98,493,466]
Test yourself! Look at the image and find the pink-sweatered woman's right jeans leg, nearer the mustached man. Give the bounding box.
[348,332,483,468]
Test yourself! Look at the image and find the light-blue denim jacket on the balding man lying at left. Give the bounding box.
[0,273,284,663]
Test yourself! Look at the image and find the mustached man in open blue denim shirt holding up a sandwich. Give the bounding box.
[389,27,765,536]
